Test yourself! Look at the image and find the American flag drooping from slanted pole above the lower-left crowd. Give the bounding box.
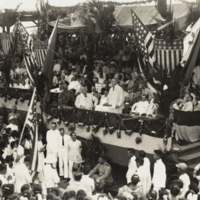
[20,88,38,172]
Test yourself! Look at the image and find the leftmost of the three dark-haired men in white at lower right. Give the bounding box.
[126,149,137,183]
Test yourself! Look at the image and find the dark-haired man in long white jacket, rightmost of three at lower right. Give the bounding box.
[152,150,167,198]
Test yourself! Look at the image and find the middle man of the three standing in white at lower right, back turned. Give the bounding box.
[136,157,151,197]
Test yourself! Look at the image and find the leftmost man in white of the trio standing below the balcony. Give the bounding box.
[46,122,60,167]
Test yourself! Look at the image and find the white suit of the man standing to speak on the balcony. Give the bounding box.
[108,84,124,113]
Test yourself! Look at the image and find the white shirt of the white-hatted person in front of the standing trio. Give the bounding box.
[44,164,60,188]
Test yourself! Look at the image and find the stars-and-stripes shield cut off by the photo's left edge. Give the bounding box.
[0,22,18,55]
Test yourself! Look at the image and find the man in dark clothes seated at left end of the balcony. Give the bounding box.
[58,83,76,107]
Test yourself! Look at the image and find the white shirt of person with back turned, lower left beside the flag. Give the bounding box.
[14,163,32,193]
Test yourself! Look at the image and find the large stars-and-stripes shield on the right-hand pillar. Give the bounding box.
[154,38,183,74]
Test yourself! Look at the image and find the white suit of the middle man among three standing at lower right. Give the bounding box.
[137,166,151,197]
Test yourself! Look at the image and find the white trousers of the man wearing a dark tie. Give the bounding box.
[58,148,69,178]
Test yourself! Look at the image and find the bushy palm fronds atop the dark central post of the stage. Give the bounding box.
[77,0,116,89]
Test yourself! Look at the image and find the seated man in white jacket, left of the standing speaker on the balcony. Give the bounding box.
[75,87,98,110]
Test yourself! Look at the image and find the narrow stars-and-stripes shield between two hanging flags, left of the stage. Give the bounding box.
[33,39,48,69]
